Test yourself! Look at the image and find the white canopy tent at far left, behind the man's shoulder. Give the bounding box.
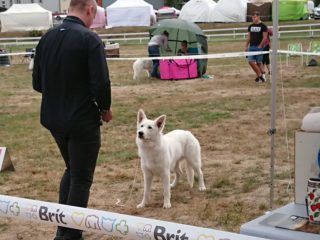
[0,3,53,32]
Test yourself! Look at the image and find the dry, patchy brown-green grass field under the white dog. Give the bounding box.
[0,25,320,240]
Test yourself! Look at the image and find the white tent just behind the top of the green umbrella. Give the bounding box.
[179,0,216,22]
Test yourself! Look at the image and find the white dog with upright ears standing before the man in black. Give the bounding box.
[136,109,206,208]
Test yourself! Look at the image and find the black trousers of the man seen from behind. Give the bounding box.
[51,125,101,240]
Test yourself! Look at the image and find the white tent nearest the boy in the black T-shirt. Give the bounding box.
[213,0,248,22]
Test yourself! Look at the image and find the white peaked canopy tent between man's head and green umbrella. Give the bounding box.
[107,0,156,27]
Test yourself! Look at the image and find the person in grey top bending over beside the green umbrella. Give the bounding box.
[148,31,171,78]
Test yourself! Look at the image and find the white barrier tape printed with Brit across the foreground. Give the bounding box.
[0,195,263,240]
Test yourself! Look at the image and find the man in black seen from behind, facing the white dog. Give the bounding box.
[32,0,112,240]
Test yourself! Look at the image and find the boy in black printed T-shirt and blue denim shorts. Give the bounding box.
[245,11,268,82]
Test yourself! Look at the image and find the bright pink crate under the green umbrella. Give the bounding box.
[160,59,198,80]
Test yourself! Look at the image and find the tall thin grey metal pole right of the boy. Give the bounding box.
[269,0,279,209]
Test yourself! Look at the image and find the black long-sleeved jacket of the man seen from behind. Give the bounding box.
[32,16,111,133]
